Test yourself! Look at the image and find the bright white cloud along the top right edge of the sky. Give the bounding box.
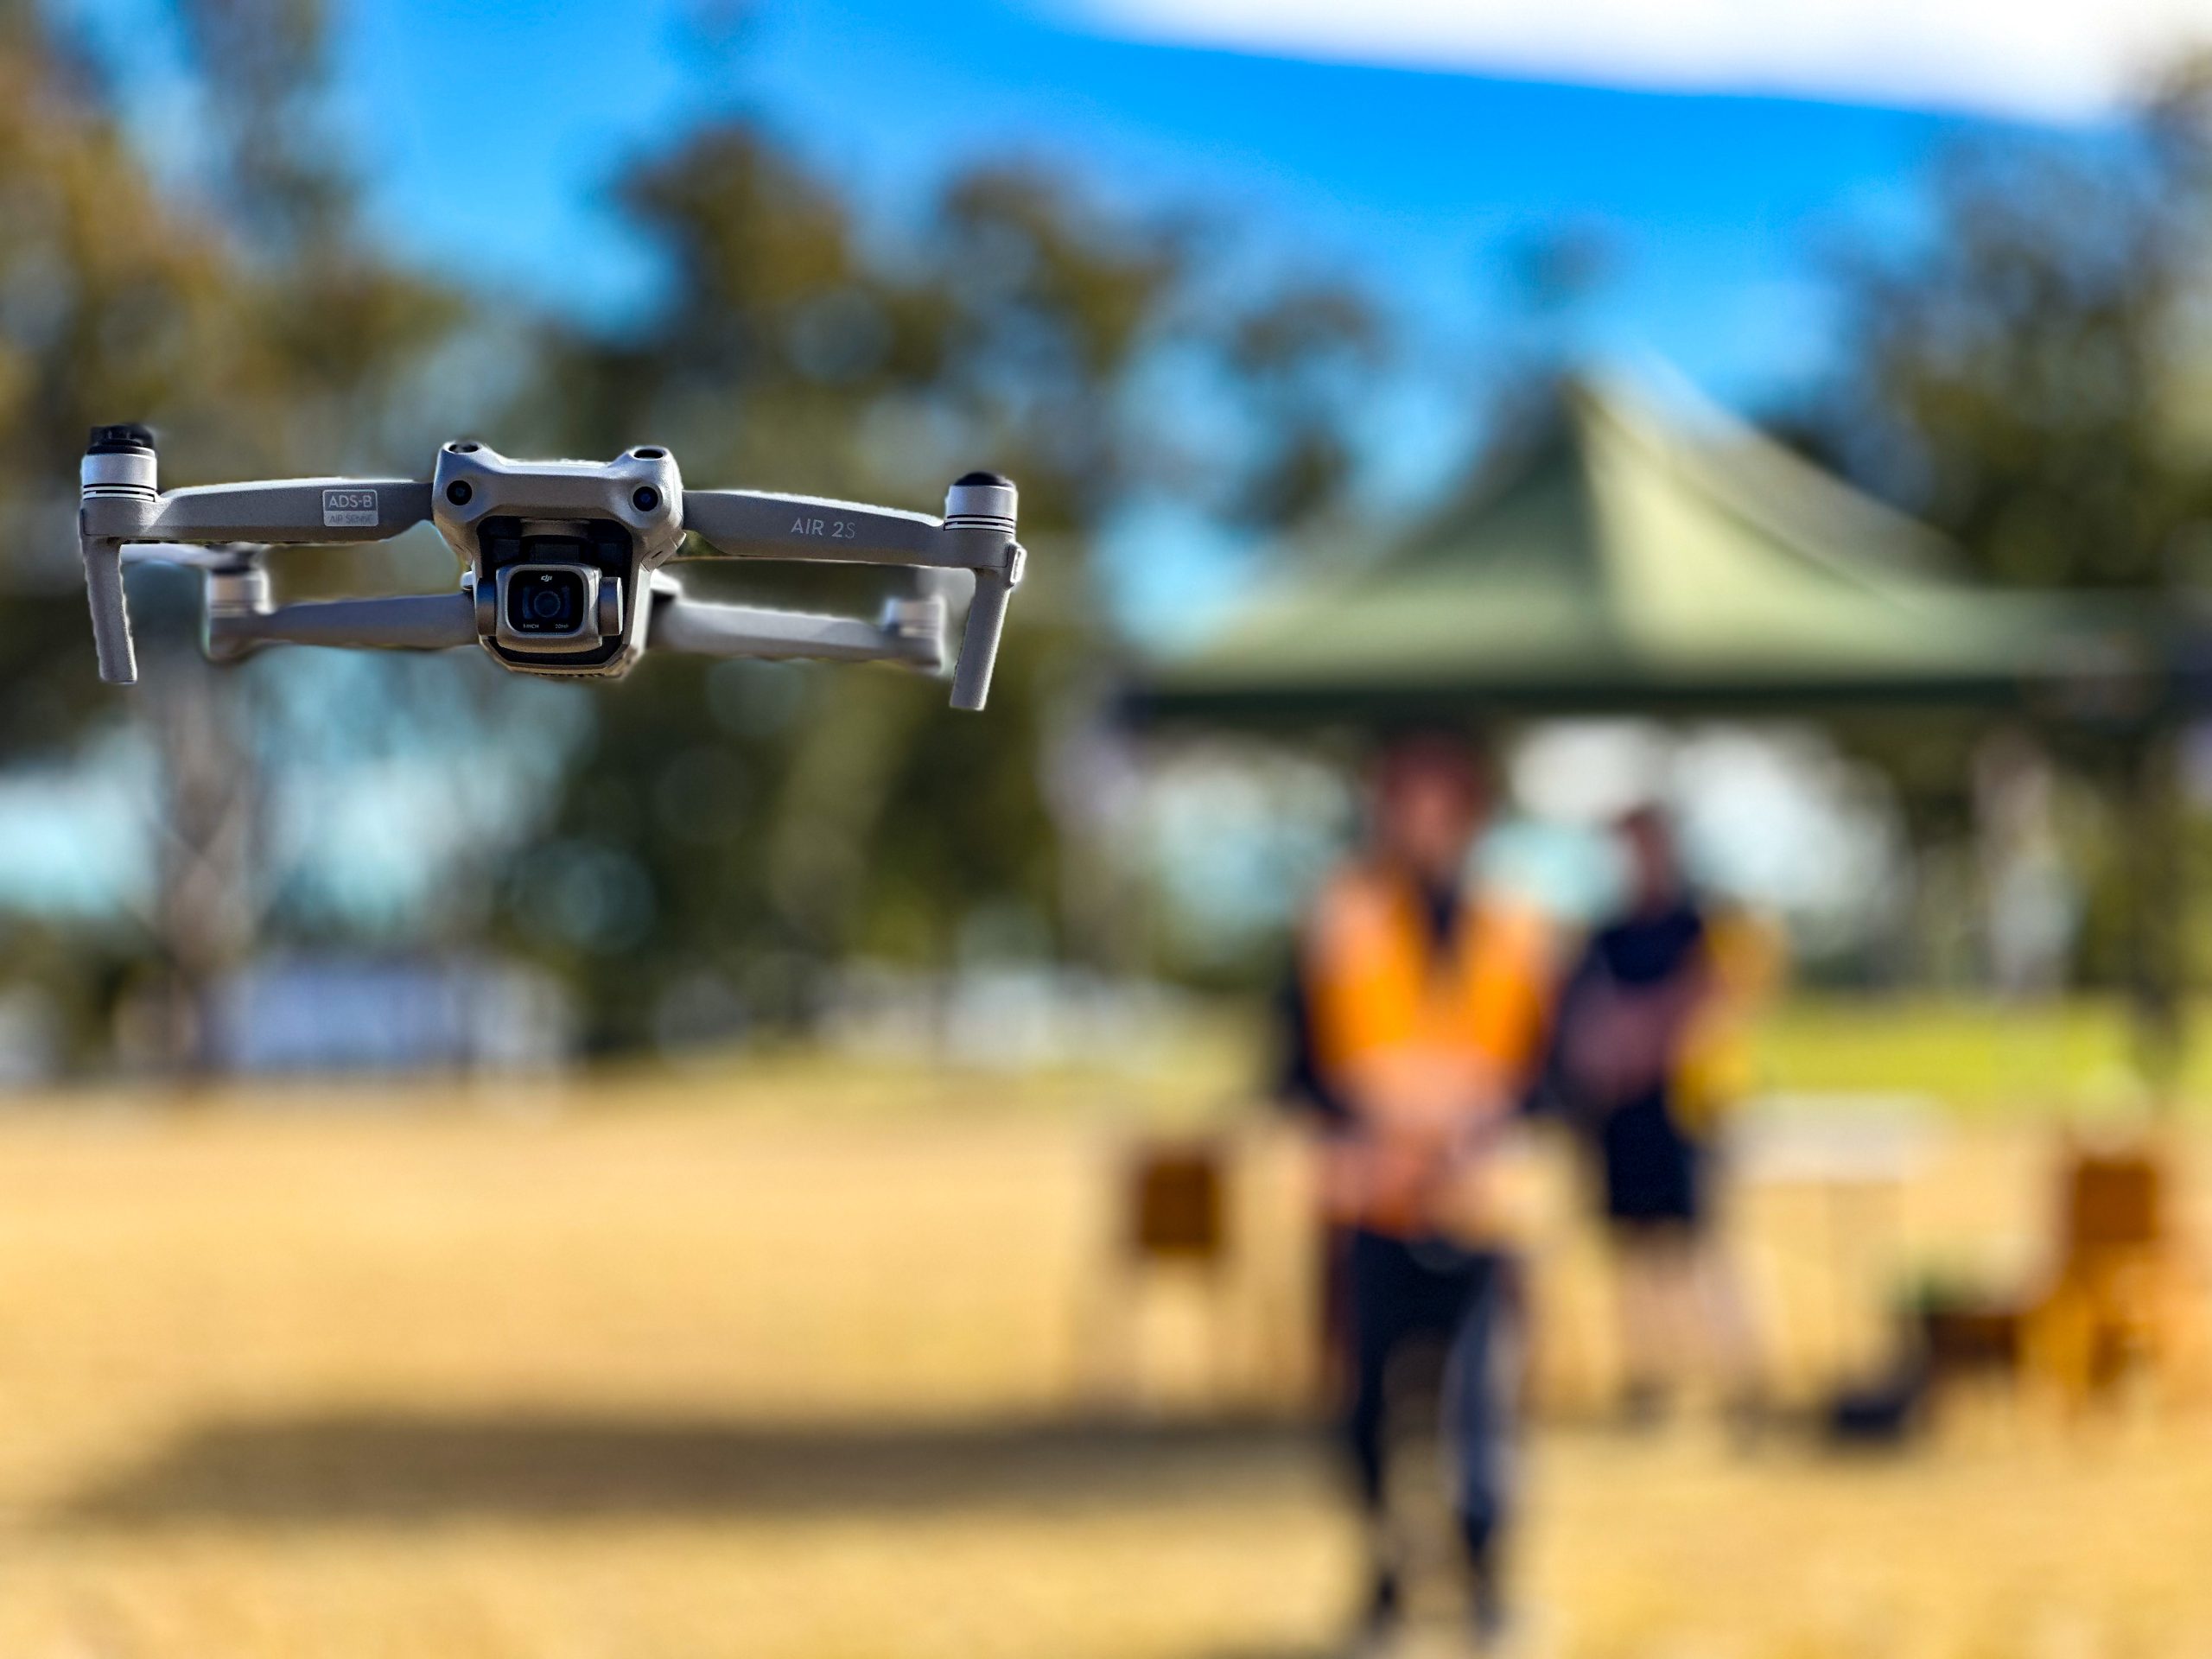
[1062,0,2212,119]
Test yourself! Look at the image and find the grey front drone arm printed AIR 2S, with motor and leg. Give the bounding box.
[683,474,1022,710]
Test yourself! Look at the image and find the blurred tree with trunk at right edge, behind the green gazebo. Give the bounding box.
[1818,62,2212,1071]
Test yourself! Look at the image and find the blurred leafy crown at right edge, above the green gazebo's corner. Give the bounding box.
[1829,68,2212,588]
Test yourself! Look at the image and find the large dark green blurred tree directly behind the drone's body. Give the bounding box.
[506,122,1376,1042]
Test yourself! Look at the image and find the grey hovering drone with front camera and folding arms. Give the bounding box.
[78,425,1024,710]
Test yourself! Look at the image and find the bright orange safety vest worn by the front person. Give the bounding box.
[1300,865,1553,1232]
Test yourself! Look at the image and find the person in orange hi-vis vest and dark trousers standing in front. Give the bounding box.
[1299,732,1551,1642]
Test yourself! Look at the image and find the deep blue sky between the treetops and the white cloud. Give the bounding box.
[311,0,2008,413]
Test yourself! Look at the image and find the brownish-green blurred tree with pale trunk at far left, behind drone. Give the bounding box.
[0,0,493,1066]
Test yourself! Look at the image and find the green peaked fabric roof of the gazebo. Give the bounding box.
[1130,380,2123,721]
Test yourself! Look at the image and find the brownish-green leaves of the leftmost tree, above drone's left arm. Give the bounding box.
[0,9,460,791]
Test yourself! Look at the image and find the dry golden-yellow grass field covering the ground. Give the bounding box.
[0,1039,2212,1659]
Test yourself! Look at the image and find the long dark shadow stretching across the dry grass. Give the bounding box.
[47,1414,1330,1526]
